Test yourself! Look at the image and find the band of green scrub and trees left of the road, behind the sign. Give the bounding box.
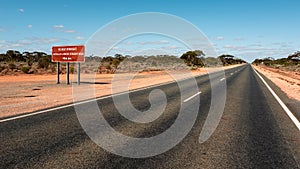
[0,50,245,75]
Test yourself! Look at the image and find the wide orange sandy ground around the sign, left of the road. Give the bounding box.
[0,65,243,118]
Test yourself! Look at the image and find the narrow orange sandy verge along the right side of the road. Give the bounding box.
[254,66,300,101]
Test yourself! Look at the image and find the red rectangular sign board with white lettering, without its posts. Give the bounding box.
[52,45,84,62]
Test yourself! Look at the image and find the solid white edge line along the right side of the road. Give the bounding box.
[252,67,300,131]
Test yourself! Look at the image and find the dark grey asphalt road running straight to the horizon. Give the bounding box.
[0,65,300,169]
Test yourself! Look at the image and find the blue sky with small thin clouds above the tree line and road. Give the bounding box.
[0,0,300,61]
